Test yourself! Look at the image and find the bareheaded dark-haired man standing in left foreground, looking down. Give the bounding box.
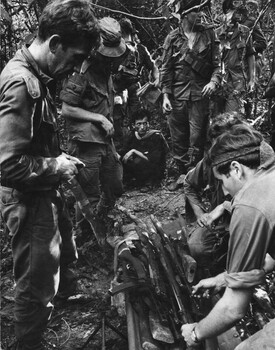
[0,0,99,350]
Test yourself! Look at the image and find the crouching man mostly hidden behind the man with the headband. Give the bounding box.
[183,112,244,274]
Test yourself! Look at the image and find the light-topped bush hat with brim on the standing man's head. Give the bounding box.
[97,17,126,57]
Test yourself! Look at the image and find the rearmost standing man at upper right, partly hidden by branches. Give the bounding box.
[216,1,256,115]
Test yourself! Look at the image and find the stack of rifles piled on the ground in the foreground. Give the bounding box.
[109,206,275,350]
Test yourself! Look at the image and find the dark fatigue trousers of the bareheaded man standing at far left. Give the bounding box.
[0,186,77,349]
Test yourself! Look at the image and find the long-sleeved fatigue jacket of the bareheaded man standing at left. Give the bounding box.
[0,47,61,191]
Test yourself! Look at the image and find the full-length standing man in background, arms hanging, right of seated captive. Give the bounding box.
[160,0,220,180]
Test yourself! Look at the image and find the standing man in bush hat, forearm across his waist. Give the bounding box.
[60,17,126,245]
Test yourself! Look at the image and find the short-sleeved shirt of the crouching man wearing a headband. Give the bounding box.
[227,157,275,273]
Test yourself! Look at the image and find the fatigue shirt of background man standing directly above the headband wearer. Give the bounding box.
[160,28,221,101]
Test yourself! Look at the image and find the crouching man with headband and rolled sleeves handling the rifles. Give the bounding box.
[182,125,275,349]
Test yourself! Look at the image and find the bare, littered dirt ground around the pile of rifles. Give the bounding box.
[0,178,188,350]
